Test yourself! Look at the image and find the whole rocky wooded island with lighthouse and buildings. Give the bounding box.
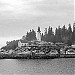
[0,23,75,59]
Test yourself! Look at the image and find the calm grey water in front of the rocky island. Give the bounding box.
[0,58,75,75]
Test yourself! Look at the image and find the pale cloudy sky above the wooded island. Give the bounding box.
[0,0,75,47]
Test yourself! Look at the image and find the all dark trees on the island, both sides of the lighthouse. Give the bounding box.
[2,23,75,49]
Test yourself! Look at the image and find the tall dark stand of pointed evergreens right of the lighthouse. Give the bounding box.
[42,23,75,46]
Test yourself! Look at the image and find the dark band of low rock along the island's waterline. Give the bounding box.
[0,54,75,59]
